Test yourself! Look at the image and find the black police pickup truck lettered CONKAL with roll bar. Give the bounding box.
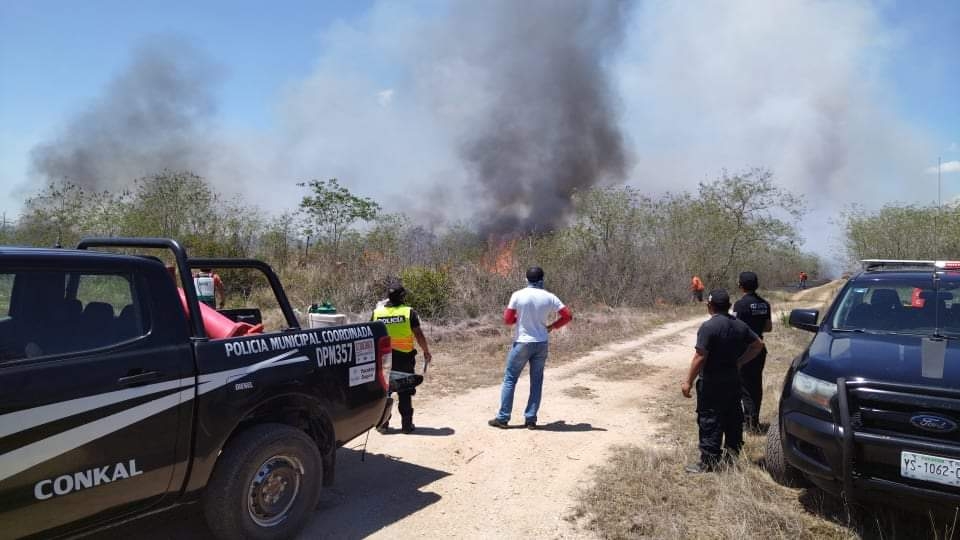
[0,238,390,538]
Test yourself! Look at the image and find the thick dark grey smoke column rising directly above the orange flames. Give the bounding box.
[455,0,627,234]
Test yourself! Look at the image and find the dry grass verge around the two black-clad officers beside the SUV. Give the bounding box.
[571,304,956,539]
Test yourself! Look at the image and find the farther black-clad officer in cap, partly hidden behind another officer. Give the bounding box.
[733,272,773,433]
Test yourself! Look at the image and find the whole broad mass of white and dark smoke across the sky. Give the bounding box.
[16,0,944,264]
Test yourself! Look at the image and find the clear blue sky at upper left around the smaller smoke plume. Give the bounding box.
[0,0,368,130]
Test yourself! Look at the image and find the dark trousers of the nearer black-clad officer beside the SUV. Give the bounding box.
[697,377,743,466]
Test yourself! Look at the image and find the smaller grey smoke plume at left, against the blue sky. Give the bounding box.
[31,40,219,190]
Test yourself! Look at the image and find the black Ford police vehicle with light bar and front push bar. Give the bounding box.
[766,260,960,506]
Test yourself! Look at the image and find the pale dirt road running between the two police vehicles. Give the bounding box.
[103,287,835,539]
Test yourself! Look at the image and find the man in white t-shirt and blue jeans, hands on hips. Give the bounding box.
[487,266,573,429]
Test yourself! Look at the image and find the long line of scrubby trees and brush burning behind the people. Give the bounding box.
[0,169,820,319]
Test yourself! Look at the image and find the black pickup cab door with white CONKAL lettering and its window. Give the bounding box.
[0,264,196,537]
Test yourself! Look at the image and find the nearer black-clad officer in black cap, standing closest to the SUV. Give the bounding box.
[680,289,763,473]
